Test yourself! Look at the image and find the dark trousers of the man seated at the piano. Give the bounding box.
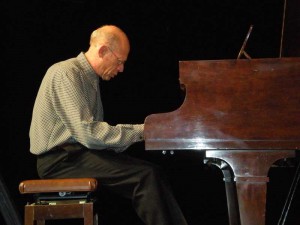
[37,147,187,225]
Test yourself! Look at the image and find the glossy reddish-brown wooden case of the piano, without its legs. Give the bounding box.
[145,58,300,150]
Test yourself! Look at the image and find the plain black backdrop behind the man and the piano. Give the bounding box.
[0,0,300,225]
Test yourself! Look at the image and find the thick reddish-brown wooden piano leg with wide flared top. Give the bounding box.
[206,150,295,225]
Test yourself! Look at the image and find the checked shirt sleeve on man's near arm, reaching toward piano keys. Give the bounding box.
[52,67,144,151]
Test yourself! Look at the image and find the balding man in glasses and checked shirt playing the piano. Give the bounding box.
[30,25,187,225]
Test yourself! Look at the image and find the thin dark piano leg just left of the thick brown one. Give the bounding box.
[204,158,241,225]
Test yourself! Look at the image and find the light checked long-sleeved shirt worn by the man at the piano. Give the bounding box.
[29,53,144,155]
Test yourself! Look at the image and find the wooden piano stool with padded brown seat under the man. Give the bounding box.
[19,178,98,225]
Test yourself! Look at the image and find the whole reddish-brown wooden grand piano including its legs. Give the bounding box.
[145,57,300,225]
